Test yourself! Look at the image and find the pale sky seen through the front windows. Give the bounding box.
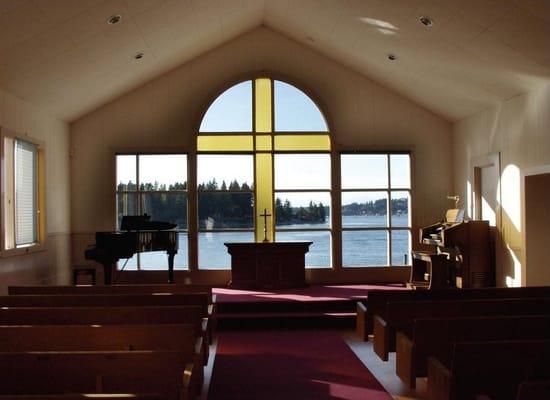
[117,81,410,205]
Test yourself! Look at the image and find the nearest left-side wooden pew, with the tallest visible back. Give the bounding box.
[0,350,196,400]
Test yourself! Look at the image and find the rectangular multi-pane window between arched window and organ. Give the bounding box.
[340,152,411,267]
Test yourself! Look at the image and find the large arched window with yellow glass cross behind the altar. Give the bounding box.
[197,77,331,269]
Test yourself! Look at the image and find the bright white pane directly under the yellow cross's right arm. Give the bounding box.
[275,154,330,190]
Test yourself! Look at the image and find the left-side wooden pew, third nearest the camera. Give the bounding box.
[0,306,211,365]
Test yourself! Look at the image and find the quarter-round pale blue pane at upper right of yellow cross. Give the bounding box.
[274,81,328,132]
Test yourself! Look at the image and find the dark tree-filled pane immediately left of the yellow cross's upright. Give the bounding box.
[198,192,254,230]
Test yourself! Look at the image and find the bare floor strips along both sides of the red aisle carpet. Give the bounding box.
[200,330,426,400]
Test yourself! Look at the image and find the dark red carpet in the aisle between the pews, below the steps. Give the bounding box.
[208,331,392,400]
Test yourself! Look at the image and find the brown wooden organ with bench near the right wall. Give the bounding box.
[409,209,494,289]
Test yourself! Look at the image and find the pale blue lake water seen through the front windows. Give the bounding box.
[124,214,410,270]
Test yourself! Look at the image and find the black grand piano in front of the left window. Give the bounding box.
[84,214,178,285]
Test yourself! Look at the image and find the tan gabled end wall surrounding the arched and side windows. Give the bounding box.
[71,28,453,284]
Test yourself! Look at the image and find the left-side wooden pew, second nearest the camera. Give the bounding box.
[0,324,204,390]
